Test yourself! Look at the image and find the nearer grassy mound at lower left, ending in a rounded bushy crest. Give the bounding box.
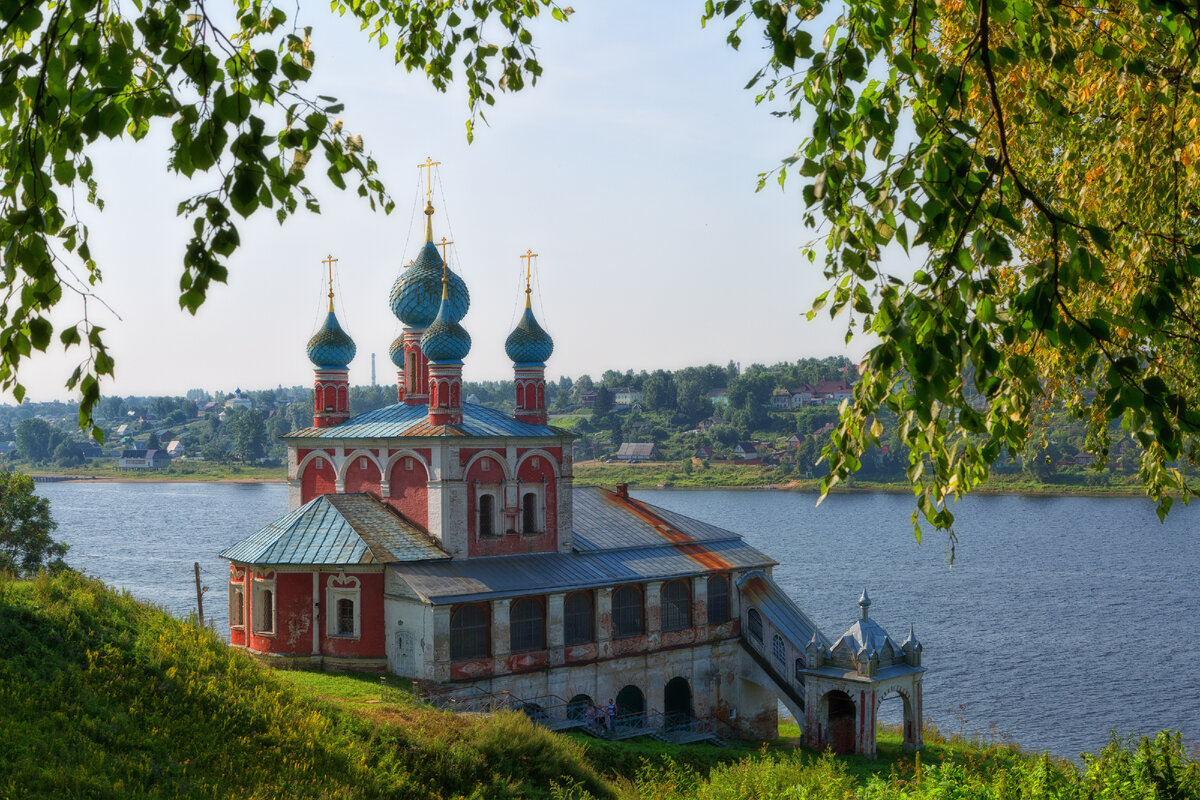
[0,573,613,800]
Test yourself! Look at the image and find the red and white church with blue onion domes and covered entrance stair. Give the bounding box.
[221,172,924,756]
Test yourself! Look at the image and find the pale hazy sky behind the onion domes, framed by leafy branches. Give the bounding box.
[9,1,863,401]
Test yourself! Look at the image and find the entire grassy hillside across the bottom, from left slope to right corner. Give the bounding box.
[0,573,1200,800]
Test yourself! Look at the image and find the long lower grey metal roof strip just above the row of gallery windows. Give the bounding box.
[389,539,774,604]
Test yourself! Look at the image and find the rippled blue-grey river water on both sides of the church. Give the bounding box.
[38,483,1200,756]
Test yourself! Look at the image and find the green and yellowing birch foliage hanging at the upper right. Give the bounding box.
[704,0,1200,536]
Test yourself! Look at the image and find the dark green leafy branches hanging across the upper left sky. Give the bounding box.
[0,0,569,438]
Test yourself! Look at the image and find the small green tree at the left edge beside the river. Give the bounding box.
[0,470,67,577]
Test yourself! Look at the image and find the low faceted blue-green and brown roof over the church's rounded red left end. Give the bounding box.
[221,494,450,566]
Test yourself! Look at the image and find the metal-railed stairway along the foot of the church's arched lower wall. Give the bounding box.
[418,685,728,747]
